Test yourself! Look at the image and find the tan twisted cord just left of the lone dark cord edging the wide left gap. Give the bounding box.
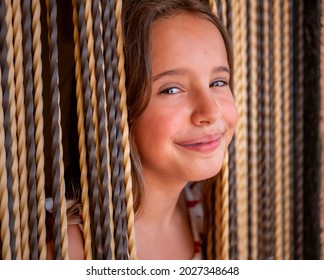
[32,0,46,260]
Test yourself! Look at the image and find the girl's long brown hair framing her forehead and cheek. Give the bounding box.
[122,0,233,212]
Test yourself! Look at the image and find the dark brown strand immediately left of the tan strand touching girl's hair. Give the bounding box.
[102,0,128,259]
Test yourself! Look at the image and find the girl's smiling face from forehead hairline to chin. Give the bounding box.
[134,13,237,187]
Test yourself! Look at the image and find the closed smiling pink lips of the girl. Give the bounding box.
[177,133,222,153]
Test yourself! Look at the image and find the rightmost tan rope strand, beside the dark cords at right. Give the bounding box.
[283,1,291,259]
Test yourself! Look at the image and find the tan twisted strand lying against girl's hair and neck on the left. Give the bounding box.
[115,0,137,260]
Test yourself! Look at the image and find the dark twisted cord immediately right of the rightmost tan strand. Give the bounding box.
[294,1,306,260]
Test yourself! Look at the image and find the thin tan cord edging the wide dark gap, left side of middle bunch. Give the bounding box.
[73,0,92,260]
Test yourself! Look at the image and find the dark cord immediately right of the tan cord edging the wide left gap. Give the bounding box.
[76,0,102,259]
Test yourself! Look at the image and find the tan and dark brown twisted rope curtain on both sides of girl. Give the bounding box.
[0,0,320,259]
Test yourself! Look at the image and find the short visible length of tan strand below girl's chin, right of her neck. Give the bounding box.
[219,151,229,260]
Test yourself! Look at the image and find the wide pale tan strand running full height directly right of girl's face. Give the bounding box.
[232,0,248,259]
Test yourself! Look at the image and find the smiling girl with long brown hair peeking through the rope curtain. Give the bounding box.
[46,0,237,259]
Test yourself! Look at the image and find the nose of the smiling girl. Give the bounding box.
[191,91,220,126]
